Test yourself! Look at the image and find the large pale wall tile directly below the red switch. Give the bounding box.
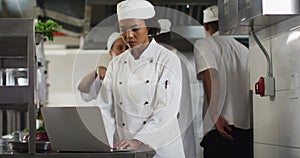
[253,91,300,148]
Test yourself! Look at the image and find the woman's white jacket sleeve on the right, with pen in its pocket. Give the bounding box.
[133,55,182,149]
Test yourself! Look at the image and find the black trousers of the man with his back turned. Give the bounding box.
[200,126,253,158]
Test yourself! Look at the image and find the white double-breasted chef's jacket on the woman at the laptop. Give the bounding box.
[97,39,185,158]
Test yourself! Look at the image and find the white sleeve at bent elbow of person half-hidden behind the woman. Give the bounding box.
[80,77,102,102]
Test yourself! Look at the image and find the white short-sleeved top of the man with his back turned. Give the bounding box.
[194,32,250,134]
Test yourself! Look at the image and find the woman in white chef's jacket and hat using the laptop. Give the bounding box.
[97,0,185,158]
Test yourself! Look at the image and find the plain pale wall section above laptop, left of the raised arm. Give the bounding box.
[45,49,103,106]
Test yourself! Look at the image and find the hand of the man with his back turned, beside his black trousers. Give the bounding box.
[215,116,233,140]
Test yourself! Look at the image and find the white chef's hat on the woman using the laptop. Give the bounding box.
[117,0,155,21]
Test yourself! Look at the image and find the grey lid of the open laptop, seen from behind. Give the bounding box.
[42,106,114,152]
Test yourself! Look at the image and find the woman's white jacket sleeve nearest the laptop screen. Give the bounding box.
[96,64,116,147]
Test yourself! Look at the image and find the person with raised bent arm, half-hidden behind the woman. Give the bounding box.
[77,32,127,102]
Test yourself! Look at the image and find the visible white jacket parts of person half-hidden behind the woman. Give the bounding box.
[79,52,111,102]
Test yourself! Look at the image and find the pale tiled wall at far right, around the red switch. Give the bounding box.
[250,16,300,158]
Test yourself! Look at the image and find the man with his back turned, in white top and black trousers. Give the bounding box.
[194,6,252,158]
